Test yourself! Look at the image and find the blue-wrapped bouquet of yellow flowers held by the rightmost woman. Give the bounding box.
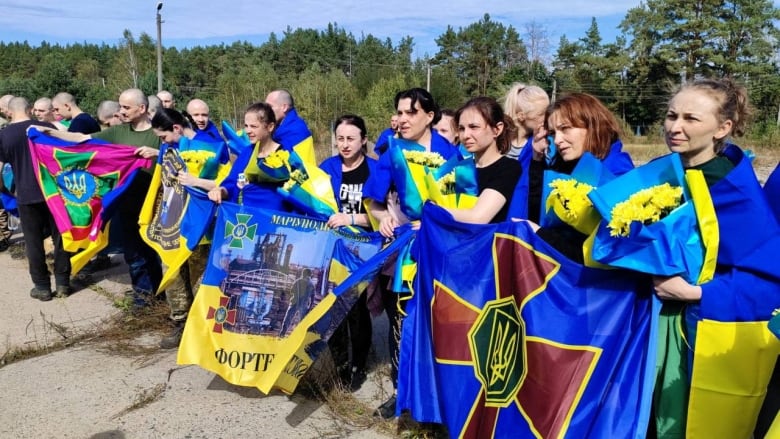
[586,154,718,283]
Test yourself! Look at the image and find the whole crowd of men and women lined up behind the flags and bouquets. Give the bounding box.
[0,79,780,437]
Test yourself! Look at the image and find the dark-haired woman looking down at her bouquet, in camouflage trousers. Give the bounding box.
[152,108,230,349]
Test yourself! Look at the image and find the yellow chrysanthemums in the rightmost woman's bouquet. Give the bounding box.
[607,183,683,236]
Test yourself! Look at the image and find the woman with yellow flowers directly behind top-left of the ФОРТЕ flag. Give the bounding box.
[209,102,289,210]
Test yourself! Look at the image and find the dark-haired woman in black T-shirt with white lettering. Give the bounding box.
[320,114,376,391]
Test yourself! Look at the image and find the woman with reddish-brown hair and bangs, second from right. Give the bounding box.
[524,93,634,263]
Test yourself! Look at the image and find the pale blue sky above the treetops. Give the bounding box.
[0,0,640,58]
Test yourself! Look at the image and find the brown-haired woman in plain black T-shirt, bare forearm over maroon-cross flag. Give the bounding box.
[447,97,522,224]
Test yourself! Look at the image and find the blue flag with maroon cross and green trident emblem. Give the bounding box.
[398,204,655,438]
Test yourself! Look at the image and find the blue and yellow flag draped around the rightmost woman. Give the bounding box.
[686,145,780,437]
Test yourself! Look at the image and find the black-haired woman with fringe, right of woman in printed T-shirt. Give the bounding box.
[363,88,457,418]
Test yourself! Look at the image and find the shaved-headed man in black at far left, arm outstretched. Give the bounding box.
[0,97,65,301]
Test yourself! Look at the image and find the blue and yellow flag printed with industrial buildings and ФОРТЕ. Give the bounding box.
[178,202,381,393]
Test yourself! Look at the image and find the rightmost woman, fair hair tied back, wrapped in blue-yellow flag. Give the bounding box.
[649,79,780,438]
